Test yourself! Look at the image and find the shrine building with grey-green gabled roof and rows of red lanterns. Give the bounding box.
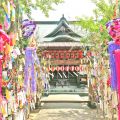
[36,16,91,86]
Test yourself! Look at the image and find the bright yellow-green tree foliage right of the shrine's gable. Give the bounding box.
[78,0,115,44]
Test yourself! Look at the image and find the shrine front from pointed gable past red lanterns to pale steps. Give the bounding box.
[38,16,91,95]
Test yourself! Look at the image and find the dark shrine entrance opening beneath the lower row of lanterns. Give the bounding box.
[50,70,87,87]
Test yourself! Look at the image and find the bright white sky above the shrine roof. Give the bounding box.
[32,0,95,21]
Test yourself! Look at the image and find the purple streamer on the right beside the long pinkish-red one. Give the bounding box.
[108,41,120,90]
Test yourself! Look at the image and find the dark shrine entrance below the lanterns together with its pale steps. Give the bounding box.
[49,66,87,94]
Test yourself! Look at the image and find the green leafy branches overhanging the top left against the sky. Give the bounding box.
[0,0,63,23]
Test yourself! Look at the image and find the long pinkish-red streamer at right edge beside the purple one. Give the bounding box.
[115,50,120,120]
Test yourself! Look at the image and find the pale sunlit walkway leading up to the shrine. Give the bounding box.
[29,95,104,120]
